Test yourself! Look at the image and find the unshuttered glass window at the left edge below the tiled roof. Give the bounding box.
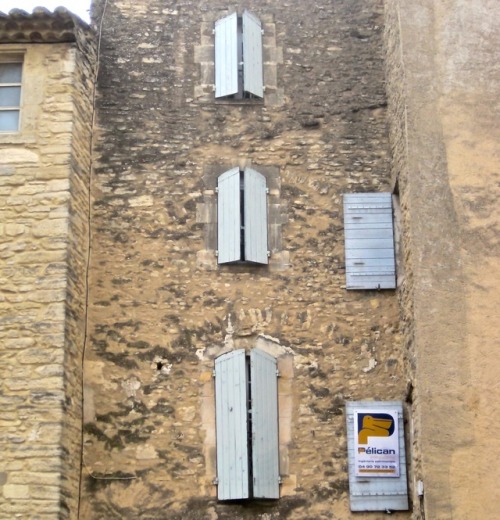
[0,58,23,132]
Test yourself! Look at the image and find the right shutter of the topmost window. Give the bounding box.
[243,11,264,97]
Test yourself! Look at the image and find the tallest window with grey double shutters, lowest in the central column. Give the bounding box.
[215,348,280,500]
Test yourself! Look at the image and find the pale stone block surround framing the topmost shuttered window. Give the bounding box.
[194,9,285,106]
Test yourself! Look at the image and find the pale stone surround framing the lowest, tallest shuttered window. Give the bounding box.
[197,315,296,497]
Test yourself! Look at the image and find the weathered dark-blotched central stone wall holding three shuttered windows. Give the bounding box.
[82,0,408,520]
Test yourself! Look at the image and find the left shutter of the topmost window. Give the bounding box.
[215,13,238,98]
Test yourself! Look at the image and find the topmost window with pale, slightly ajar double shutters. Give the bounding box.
[215,11,264,99]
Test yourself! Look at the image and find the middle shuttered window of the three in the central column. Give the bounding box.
[217,168,269,264]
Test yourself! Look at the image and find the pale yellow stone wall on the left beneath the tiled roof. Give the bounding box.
[0,13,93,519]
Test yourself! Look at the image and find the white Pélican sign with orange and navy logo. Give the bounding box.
[354,408,399,477]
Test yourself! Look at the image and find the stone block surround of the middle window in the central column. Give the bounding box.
[196,159,290,271]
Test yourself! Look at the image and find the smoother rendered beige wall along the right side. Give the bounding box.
[386,0,500,519]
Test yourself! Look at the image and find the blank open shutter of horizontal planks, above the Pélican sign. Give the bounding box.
[344,193,396,289]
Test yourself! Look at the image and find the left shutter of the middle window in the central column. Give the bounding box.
[217,168,241,264]
